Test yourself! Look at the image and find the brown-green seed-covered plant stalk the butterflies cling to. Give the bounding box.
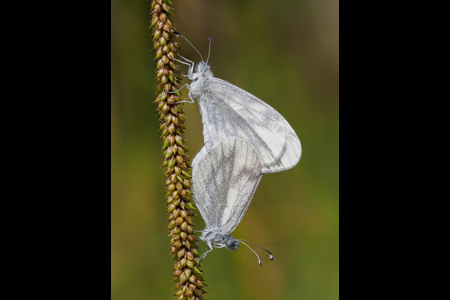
[150,0,206,300]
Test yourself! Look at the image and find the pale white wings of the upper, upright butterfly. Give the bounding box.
[198,78,302,174]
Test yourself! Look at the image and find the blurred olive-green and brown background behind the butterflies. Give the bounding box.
[111,0,339,300]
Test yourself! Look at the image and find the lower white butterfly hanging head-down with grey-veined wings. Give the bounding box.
[192,139,273,265]
